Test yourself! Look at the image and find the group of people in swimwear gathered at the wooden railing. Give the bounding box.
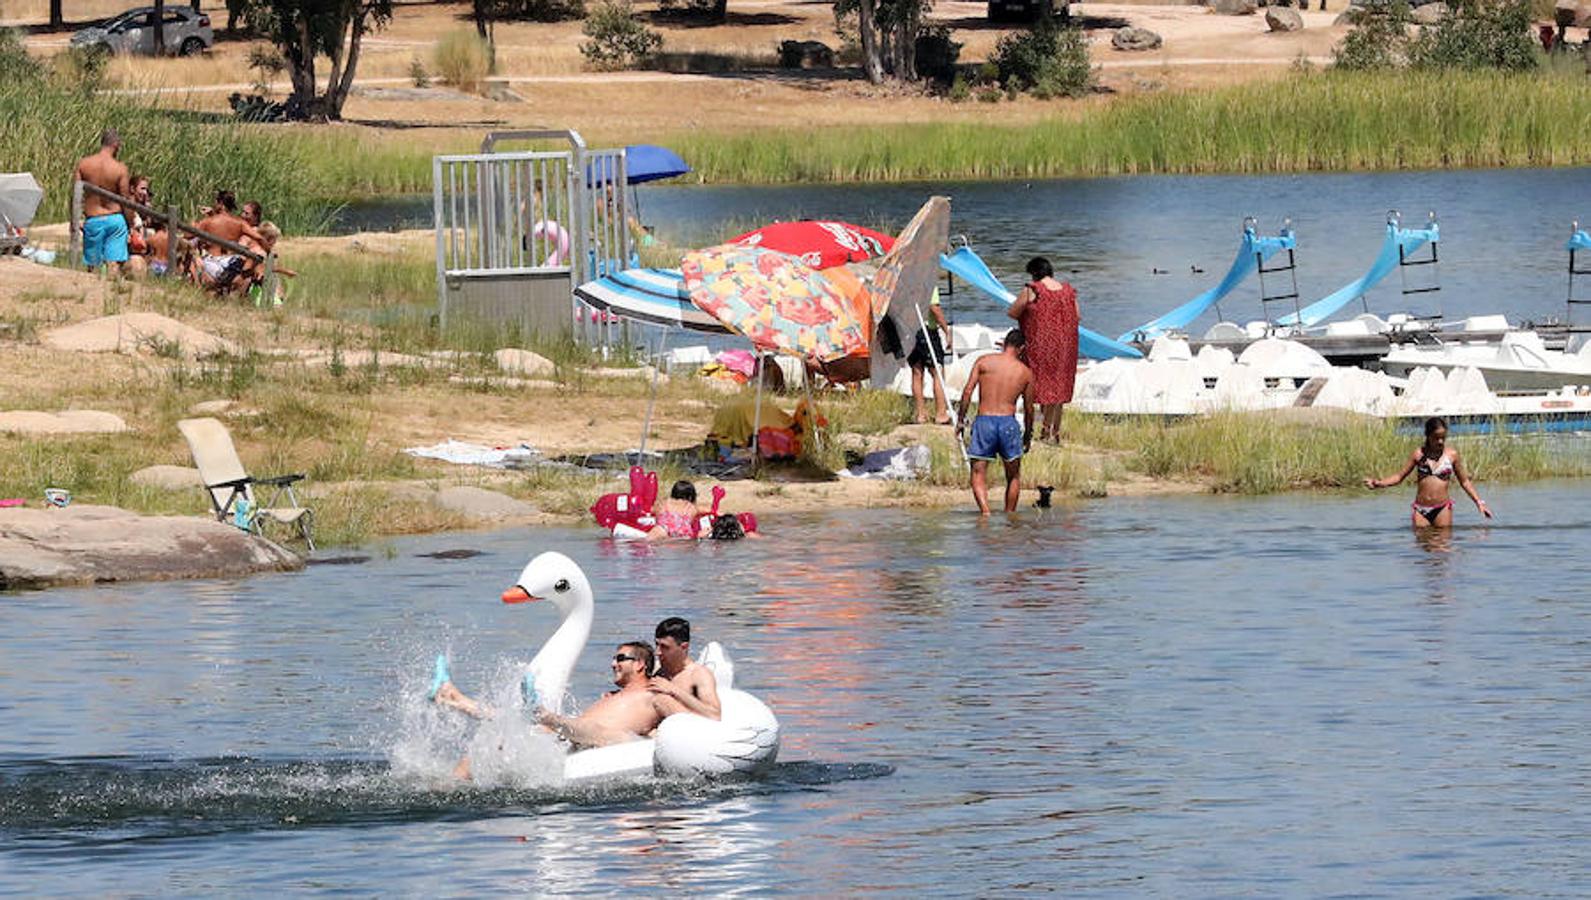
[73,129,293,304]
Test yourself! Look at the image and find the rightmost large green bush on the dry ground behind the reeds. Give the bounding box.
[1408,0,1540,72]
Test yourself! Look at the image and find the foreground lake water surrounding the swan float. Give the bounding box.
[0,480,1591,897]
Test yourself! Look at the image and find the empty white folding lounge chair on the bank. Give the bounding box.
[177,418,315,550]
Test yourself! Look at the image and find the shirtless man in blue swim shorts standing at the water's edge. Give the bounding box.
[956,328,1034,515]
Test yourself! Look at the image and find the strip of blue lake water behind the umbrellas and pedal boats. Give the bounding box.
[337,169,1591,336]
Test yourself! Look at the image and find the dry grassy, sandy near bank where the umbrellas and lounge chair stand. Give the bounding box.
[0,251,1591,545]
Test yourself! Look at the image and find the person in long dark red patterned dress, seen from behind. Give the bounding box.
[1007,256,1077,444]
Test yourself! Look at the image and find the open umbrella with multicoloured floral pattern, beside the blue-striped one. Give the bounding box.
[679,243,867,363]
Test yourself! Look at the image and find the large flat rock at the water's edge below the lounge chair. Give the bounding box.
[0,506,304,588]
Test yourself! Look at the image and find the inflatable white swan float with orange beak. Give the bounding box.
[445,552,780,781]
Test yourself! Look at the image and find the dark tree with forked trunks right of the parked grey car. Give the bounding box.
[247,0,393,121]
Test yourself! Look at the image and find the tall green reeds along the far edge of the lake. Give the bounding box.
[15,72,1591,234]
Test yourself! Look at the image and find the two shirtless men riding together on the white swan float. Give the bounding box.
[431,615,722,779]
